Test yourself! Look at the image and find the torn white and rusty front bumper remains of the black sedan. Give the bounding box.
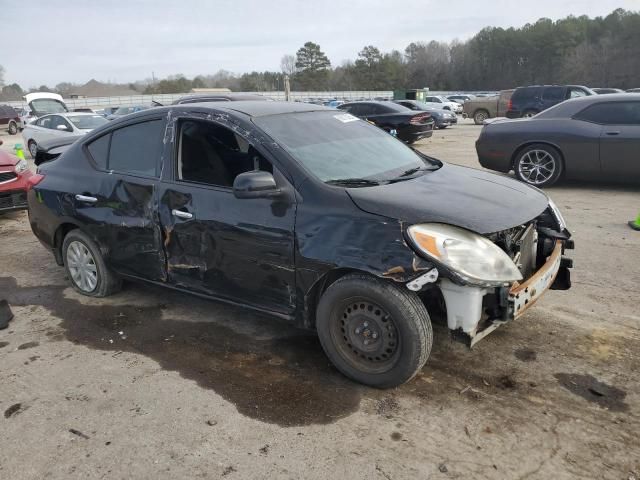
[440,240,569,346]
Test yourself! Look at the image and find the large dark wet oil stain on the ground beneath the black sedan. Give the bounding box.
[0,277,366,426]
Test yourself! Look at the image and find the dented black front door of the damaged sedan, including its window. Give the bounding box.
[159,117,296,315]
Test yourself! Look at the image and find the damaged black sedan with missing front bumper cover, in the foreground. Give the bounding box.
[28,102,572,388]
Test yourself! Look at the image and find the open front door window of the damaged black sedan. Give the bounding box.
[178,120,273,188]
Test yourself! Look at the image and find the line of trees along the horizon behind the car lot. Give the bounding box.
[0,9,640,100]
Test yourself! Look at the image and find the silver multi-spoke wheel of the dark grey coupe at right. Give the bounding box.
[513,144,562,187]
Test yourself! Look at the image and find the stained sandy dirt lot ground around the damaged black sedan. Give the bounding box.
[0,122,640,480]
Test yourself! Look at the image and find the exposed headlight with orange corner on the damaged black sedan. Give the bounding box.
[407,223,522,286]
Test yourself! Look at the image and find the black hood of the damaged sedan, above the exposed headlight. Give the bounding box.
[347,163,549,235]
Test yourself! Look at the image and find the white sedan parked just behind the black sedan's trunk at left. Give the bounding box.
[22,112,108,158]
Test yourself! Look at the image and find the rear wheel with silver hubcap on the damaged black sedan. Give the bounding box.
[62,230,121,297]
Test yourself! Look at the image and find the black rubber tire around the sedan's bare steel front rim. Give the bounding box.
[316,274,433,388]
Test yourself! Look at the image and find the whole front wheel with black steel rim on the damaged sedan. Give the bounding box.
[316,274,433,388]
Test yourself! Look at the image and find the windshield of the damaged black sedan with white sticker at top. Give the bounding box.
[254,112,441,186]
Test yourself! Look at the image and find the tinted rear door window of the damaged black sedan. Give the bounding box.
[108,120,164,176]
